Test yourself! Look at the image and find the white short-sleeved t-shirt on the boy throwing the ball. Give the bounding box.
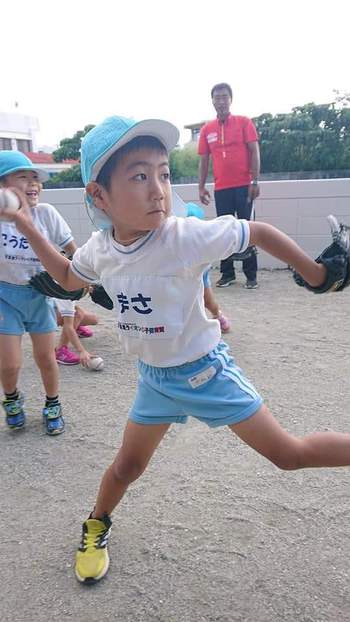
[71,216,249,367]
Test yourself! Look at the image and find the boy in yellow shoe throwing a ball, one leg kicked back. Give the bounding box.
[7,117,350,583]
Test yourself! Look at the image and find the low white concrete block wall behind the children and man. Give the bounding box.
[42,179,350,268]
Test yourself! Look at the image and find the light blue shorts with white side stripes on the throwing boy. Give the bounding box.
[129,342,263,428]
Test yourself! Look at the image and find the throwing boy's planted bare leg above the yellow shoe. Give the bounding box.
[92,421,170,518]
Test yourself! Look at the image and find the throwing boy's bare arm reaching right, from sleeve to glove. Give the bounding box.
[249,221,327,287]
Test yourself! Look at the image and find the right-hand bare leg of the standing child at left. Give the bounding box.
[30,333,59,397]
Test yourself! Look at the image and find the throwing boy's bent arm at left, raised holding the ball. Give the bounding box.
[10,190,86,291]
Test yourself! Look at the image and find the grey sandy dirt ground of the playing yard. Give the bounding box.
[0,271,350,622]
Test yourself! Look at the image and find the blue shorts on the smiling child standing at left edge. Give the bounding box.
[0,281,57,335]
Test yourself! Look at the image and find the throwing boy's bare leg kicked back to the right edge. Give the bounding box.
[229,406,350,470]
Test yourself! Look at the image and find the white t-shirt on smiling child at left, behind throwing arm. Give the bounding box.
[0,203,73,285]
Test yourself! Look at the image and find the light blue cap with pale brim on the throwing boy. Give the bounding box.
[81,117,180,186]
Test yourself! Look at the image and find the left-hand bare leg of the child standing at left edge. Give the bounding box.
[0,335,22,394]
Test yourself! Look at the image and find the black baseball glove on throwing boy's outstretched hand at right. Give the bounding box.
[293,216,350,294]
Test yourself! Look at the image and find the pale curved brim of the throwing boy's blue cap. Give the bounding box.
[89,119,180,181]
